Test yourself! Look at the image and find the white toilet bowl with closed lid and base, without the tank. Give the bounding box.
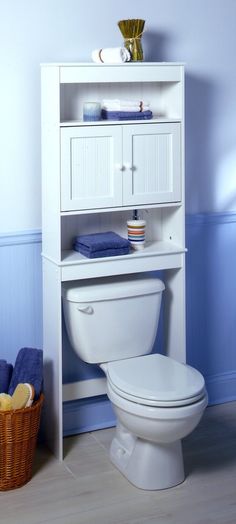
[102,354,207,490]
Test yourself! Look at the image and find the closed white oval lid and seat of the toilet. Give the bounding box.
[107,354,205,407]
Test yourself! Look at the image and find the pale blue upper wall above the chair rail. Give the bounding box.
[0,0,236,233]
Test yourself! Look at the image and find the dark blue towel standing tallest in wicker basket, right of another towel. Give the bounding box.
[8,348,43,400]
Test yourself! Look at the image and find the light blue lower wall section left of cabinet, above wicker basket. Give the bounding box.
[0,231,42,363]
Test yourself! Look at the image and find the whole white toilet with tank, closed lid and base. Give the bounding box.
[62,275,207,490]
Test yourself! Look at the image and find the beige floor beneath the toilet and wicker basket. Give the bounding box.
[0,402,236,524]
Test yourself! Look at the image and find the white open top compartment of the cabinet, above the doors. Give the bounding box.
[52,62,184,125]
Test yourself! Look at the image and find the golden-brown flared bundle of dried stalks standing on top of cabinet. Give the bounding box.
[118,18,145,61]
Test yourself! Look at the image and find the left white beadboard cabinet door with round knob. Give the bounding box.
[61,125,122,211]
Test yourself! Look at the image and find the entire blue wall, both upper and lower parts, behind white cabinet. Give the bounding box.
[0,0,236,427]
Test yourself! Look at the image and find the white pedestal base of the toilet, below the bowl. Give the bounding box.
[110,424,185,490]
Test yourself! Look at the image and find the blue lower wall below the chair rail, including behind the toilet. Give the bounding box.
[0,213,236,434]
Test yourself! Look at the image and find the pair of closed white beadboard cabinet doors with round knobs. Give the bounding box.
[61,123,181,211]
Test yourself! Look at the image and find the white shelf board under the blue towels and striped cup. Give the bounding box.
[58,242,186,281]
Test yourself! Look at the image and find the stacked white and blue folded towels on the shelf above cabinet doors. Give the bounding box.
[102,99,153,120]
